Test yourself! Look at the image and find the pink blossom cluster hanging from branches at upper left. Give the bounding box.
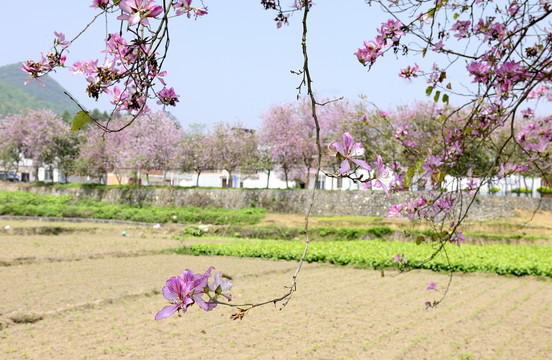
[21,0,207,115]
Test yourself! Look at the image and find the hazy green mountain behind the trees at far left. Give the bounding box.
[0,63,79,115]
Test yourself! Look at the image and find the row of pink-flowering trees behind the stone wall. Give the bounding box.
[0,101,544,187]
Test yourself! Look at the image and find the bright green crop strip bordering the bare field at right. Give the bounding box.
[189,240,552,276]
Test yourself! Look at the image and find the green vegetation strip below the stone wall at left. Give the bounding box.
[0,191,265,225]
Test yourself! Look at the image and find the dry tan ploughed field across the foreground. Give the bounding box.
[0,220,552,360]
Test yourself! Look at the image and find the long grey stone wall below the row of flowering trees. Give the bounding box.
[10,185,552,219]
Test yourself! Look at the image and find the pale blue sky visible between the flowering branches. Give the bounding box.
[5,0,544,128]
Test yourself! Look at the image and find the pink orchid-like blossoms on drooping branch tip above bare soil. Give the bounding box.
[155,266,232,320]
